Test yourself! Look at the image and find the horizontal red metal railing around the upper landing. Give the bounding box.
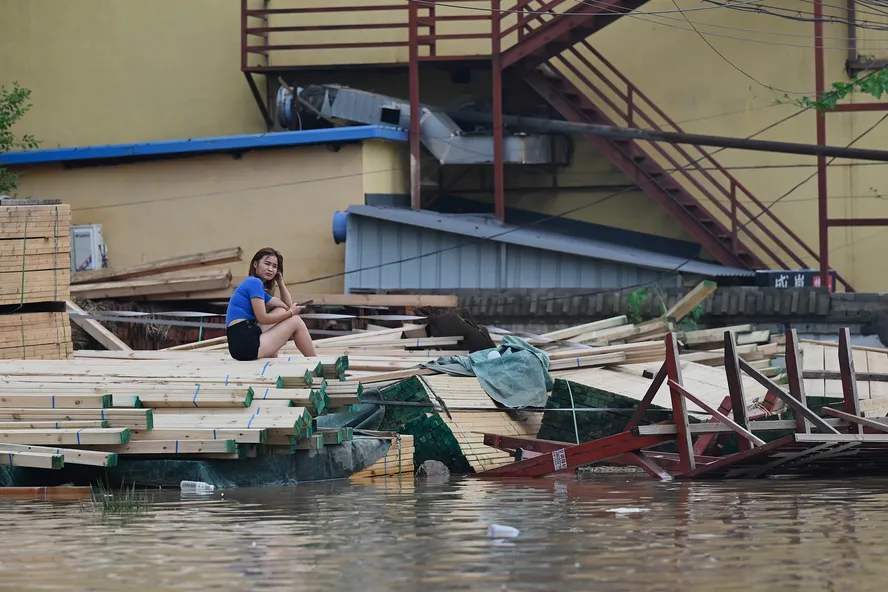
[241,0,491,72]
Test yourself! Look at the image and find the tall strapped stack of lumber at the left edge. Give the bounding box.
[0,200,73,360]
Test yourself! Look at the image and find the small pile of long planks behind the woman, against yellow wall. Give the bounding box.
[71,247,243,300]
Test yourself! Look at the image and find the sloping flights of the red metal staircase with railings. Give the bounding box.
[502,0,853,291]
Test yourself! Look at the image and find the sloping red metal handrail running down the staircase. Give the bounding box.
[553,40,852,290]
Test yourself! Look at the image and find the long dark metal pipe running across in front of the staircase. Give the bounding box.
[447,111,888,162]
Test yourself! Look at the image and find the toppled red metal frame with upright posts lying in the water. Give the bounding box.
[477,328,888,481]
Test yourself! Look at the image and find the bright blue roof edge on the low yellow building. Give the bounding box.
[0,125,407,166]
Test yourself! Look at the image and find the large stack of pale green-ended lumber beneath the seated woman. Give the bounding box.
[0,352,351,468]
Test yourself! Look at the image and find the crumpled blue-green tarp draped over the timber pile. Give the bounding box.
[425,335,554,409]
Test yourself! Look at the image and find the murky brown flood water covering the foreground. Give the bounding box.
[0,475,888,592]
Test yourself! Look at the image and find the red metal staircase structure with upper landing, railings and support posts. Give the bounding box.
[241,0,888,291]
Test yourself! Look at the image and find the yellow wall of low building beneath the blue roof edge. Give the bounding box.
[11,144,363,294]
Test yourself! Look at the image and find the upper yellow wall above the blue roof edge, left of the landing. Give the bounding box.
[0,0,265,148]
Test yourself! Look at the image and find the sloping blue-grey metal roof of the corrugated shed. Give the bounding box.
[348,206,755,277]
